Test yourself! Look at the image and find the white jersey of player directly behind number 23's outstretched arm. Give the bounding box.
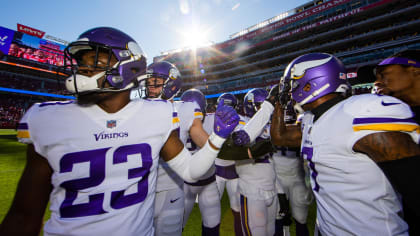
[156,101,203,192]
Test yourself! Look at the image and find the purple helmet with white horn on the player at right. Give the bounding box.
[283,53,350,106]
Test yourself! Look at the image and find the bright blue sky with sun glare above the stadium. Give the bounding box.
[0,0,309,62]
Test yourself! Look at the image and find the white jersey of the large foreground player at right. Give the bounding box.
[301,94,419,235]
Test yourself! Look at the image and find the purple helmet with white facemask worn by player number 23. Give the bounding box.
[64,27,147,94]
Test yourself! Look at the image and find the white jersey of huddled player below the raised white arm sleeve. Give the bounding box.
[236,117,277,200]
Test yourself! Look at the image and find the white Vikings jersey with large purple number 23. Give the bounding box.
[18,100,178,236]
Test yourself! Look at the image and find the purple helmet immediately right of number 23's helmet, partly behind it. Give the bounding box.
[146,61,182,100]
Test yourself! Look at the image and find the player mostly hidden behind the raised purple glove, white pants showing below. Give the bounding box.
[213,93,245,236]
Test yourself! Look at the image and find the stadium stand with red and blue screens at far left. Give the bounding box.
[0,27,69,129]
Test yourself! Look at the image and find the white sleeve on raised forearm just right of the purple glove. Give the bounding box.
[243,101,274,142]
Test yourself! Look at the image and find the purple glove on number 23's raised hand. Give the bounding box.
[213,99,239,138]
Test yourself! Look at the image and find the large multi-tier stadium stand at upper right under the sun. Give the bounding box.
[154,0,420,95]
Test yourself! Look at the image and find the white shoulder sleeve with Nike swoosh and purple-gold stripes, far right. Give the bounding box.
[345,94,420,150]
